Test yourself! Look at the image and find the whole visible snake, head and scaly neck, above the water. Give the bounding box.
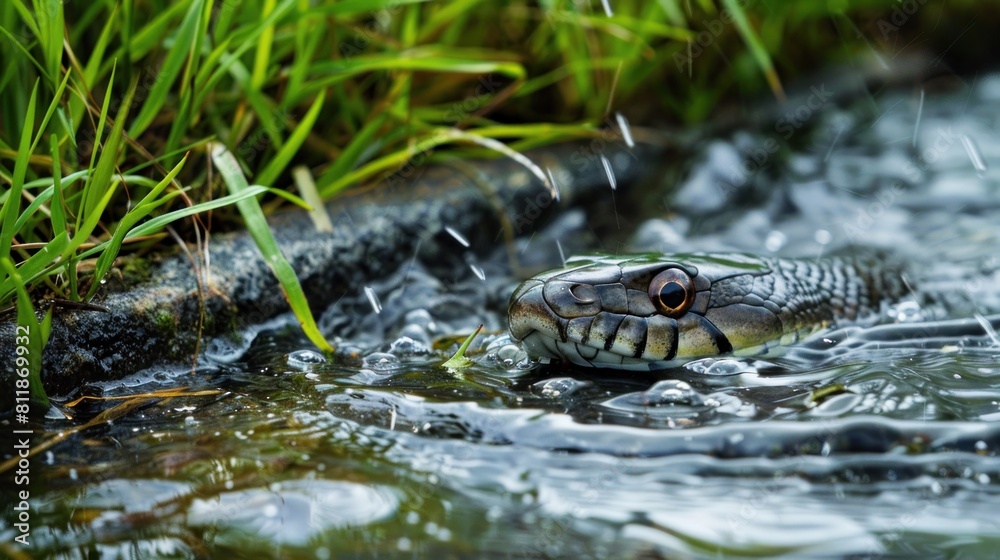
[508,253,909,370]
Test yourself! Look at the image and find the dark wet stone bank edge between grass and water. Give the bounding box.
[0,139,664,409]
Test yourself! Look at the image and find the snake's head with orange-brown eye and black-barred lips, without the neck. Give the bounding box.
[508,254,782,370]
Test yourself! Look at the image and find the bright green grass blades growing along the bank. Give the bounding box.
[0,0,973,402]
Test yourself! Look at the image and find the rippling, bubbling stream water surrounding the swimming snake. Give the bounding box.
[0,77,1000,559]
